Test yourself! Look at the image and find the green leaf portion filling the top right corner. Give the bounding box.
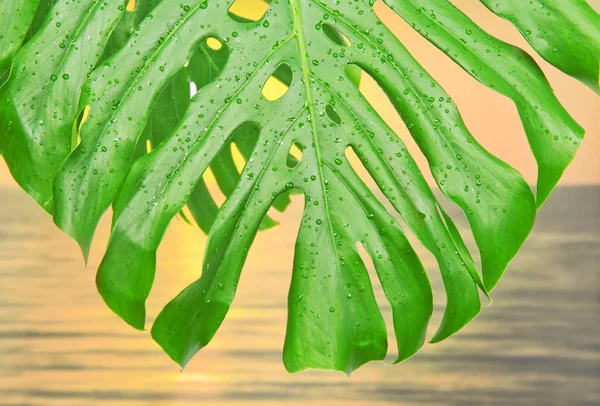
[481,0,600,94]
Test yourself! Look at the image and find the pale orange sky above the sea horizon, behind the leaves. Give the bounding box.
[0,0,600,185]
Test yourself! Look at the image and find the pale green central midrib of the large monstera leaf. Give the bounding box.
[290,0,356,359]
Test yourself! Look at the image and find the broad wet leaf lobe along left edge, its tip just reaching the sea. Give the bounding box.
[0,0,125,212]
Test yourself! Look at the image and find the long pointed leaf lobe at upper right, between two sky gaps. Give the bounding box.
[386,0,584,207]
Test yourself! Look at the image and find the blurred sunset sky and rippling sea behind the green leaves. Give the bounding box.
[0,0,600,406]
